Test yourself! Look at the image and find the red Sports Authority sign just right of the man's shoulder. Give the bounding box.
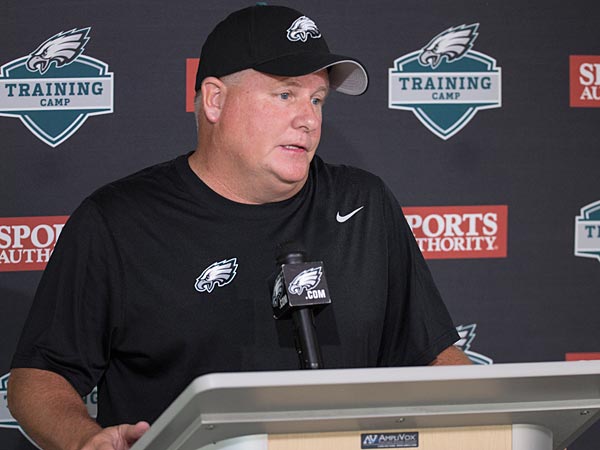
[402,205,508,259]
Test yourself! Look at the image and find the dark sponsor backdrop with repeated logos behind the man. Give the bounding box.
[0,0,600,450]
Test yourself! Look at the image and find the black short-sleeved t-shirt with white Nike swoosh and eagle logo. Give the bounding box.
[12,155,458,426]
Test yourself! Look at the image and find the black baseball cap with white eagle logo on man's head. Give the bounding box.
[196,5,369,95]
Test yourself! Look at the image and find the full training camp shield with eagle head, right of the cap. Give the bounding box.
[388,23,502,140]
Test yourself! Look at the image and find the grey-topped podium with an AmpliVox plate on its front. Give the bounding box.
[132,361,600,450]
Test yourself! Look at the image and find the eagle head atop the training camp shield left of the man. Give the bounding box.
[27,28,90,75]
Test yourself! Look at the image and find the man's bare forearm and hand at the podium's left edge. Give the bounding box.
[8,369,150,450]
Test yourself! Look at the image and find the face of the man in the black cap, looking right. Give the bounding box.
[215,70,329,203]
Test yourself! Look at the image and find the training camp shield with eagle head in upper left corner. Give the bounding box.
[0,27,113,147]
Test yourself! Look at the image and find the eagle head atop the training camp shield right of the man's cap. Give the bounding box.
[419,23,479,69]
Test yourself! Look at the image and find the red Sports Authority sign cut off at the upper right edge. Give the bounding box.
[569,55,600,108]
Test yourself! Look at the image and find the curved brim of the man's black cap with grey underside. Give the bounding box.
[253,53,369,95]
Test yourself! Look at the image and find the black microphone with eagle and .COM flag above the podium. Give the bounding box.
[271,242,331,369]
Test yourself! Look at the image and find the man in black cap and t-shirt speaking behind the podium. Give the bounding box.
[8,6,468,450]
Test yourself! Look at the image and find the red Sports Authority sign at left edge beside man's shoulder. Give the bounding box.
[0,216,69,272]
